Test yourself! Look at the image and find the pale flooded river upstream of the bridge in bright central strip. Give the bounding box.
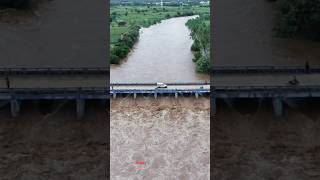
[110,16,209,83]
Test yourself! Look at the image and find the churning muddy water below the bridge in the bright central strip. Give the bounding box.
[110,97,210,180]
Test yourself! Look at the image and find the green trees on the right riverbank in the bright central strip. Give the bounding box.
[186,13,210,73]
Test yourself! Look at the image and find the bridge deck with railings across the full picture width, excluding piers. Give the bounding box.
[0,69,320,99]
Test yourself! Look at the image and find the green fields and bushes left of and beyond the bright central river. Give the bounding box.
[109,5,209,64]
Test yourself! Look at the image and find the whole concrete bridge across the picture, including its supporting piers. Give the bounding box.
[0,67,320,118]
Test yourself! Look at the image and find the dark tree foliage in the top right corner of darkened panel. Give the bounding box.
[275,0,320,40]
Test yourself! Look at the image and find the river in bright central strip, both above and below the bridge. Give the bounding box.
[110,17,210,180]
